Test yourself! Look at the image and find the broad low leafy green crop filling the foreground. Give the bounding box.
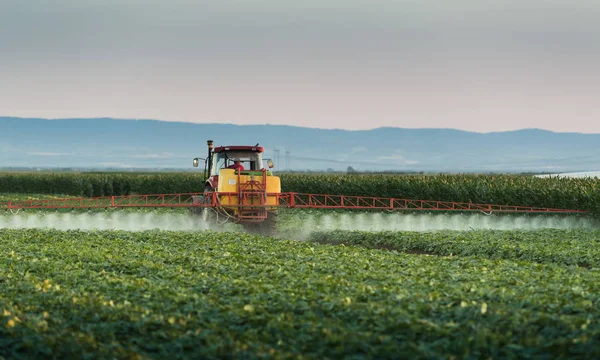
[0,230,600,359]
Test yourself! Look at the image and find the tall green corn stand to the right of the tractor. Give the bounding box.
[281,174,600,213]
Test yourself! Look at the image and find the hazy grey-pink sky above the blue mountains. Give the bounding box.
[0,0,600,133]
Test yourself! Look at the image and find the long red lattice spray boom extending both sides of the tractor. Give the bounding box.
[0,189,587,213]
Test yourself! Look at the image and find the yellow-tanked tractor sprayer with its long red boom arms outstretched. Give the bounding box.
[0,140,588,235]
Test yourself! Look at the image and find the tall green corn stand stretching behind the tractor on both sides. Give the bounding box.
[0,173,600,213]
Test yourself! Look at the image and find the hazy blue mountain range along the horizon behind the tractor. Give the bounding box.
[0,117,600,172]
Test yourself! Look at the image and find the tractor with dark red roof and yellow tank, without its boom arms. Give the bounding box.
[190,140,281,235]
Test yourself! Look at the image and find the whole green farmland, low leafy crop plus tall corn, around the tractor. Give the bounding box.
[0,174,600,360]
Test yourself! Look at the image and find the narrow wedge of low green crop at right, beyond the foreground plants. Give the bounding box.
[308,229,600,268]
